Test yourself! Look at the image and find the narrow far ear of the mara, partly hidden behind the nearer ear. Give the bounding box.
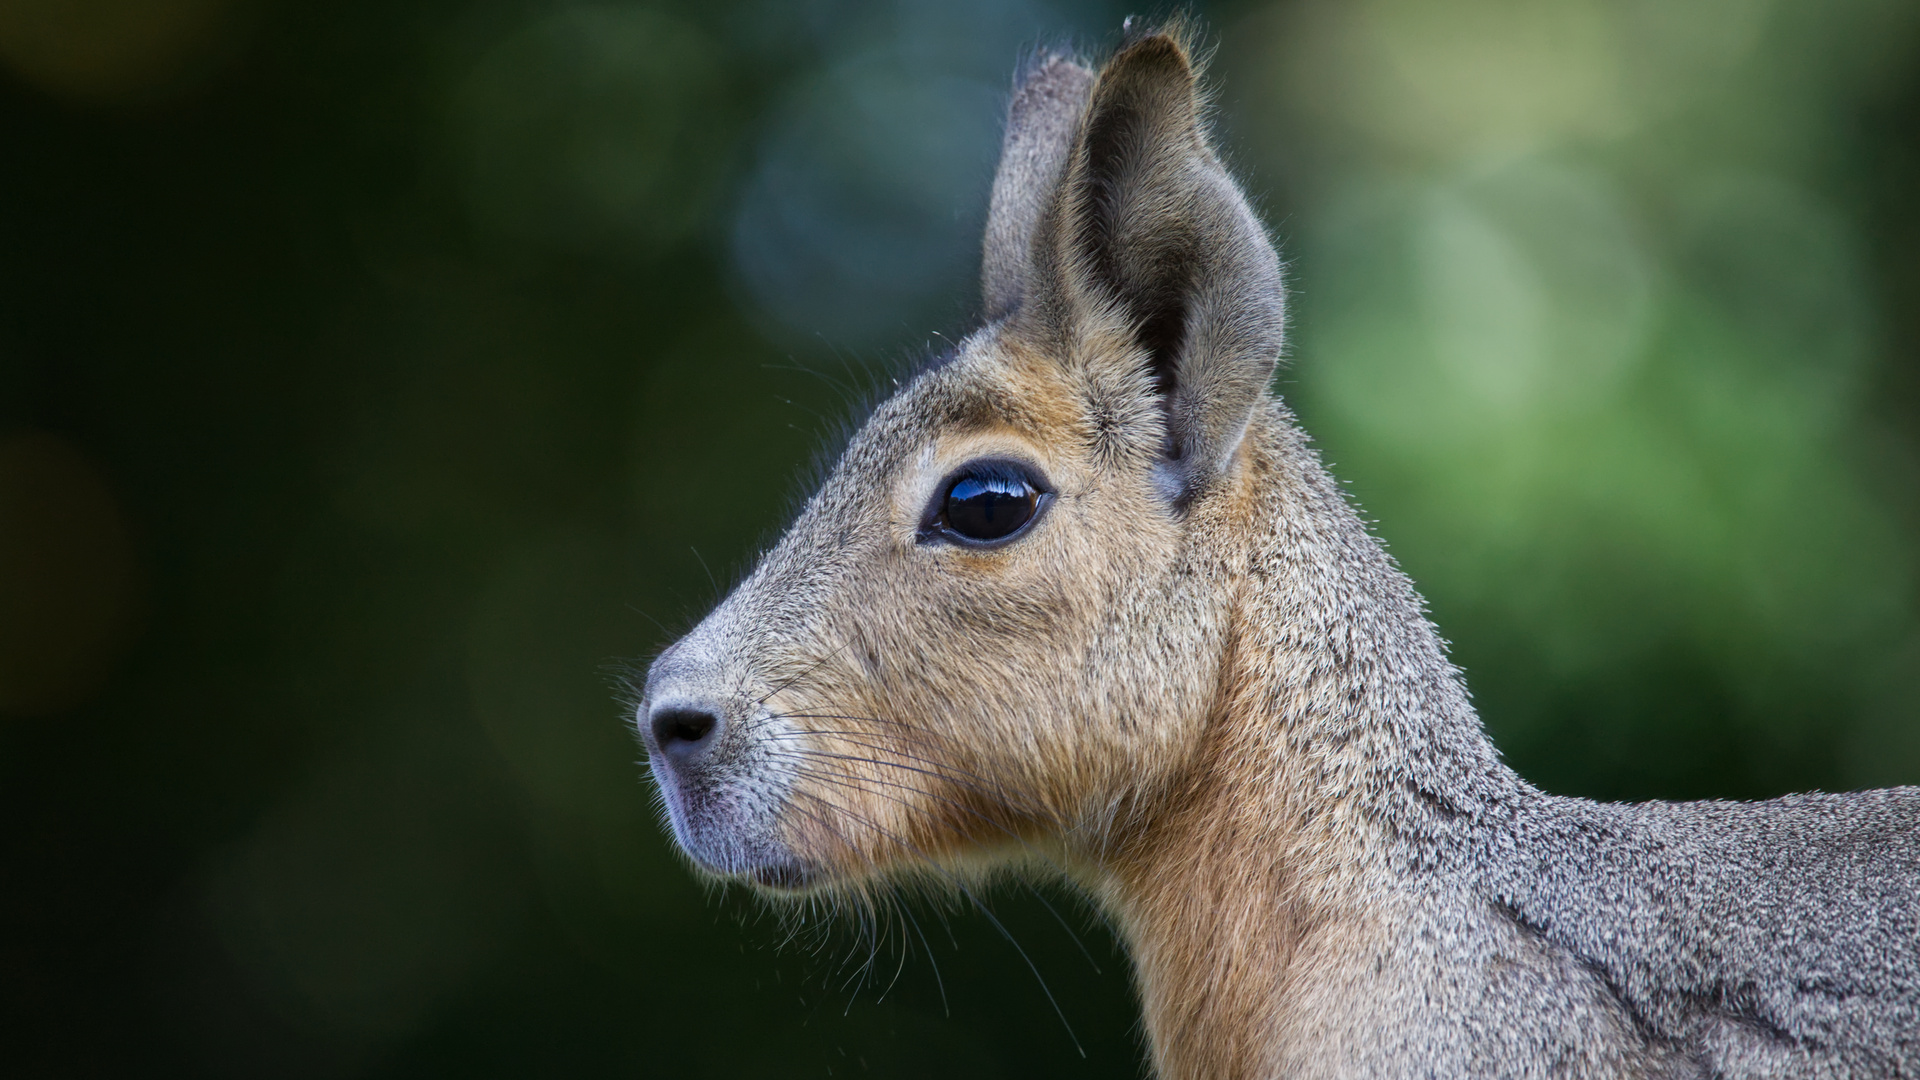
[979,52,1094,321]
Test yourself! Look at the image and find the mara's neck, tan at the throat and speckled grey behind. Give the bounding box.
[1096,409,1526,1080]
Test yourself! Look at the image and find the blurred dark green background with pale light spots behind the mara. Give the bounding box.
[0,0,1920,1078]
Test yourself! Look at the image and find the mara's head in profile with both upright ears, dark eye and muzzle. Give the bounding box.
[636,31,1284,892]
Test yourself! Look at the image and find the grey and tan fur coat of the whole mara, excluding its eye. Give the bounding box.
[636,27,1920,1080]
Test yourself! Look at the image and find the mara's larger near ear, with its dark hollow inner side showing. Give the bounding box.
[1029,29,1286,505]
